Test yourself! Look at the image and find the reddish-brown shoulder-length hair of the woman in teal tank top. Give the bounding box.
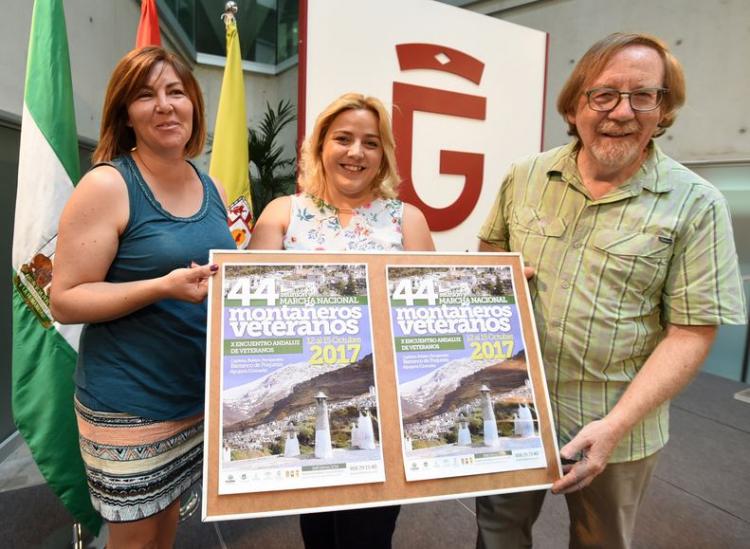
[92,46,206,163]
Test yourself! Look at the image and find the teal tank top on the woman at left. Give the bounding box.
[75,155,235,420]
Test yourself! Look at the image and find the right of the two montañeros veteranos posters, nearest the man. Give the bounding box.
[387,265,546,481]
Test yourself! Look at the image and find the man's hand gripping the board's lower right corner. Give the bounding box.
[552,418,621,494]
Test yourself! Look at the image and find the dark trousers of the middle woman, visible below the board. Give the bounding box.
[299,505,401,549]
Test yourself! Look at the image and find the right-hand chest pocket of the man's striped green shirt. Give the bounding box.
[592,229,674,296]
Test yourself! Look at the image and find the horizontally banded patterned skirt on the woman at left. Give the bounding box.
[75,400,203,522]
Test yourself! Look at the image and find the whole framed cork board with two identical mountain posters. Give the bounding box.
[203,251,561,520]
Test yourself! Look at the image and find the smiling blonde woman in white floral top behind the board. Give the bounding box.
[250,93,435,549]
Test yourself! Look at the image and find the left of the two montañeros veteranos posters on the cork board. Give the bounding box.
[219,264,385,494]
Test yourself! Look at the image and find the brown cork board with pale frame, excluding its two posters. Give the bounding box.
[202,251,561,521]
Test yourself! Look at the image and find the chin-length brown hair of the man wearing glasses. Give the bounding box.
[557,32,685,137]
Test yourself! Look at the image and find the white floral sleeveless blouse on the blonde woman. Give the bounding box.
[284,193,404,252]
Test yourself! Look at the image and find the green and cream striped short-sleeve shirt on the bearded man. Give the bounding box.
[479,143,746,463]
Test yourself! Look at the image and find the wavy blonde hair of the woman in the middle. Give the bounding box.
[298,93,400,198]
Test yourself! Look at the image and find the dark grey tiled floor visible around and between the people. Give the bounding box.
[0,374,750,549]
